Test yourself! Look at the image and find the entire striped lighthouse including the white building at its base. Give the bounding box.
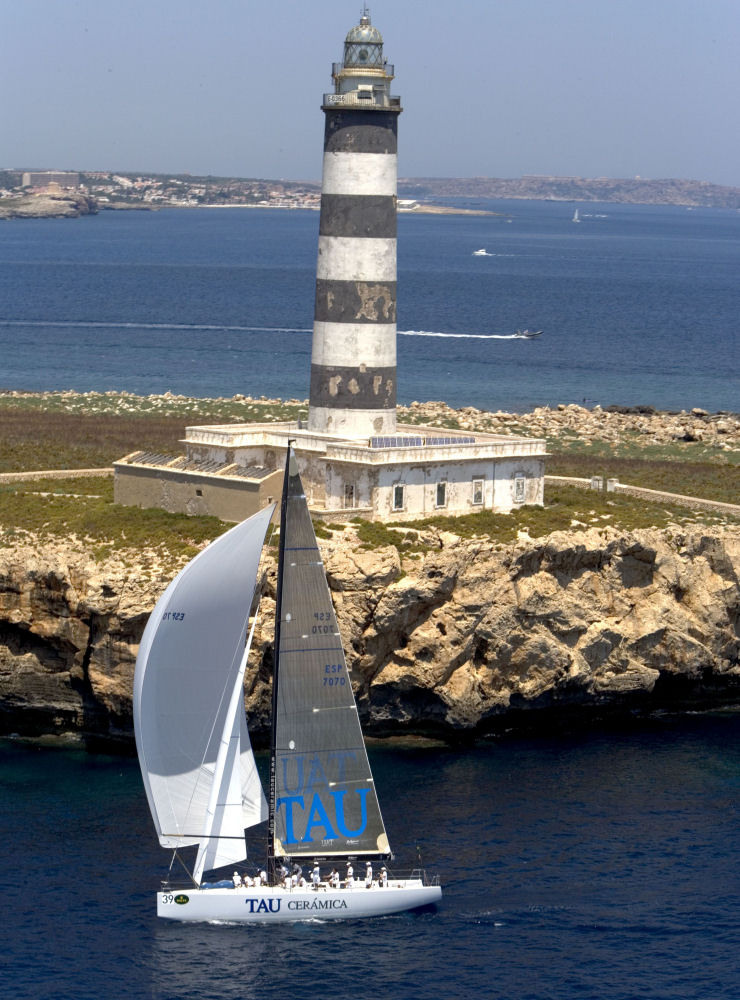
[115,8,546,525]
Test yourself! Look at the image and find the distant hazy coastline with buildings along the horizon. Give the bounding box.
[0,170,740,219]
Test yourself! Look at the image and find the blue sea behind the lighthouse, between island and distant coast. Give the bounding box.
[0,201,740,411]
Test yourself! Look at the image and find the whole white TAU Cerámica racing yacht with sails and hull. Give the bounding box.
[134,447,442,923]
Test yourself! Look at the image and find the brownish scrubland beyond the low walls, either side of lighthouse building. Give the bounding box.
[0,393,740,503]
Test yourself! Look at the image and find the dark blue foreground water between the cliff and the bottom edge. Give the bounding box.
[0,714,740,1000]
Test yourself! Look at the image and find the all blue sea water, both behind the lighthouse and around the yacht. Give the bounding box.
[0,202,740,1000]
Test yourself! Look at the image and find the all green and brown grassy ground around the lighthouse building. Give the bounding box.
[0,393,740,558]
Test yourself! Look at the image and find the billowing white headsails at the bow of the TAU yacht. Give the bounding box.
[134,505,274,864]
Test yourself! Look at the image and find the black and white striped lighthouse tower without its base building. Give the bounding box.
[308,8,401,438]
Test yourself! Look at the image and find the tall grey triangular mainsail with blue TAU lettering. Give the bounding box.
[271,449,390,857]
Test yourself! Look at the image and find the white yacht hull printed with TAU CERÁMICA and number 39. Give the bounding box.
[157,879,442,924]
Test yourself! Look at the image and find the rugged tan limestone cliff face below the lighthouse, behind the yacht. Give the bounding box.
[0,528,740,742]
